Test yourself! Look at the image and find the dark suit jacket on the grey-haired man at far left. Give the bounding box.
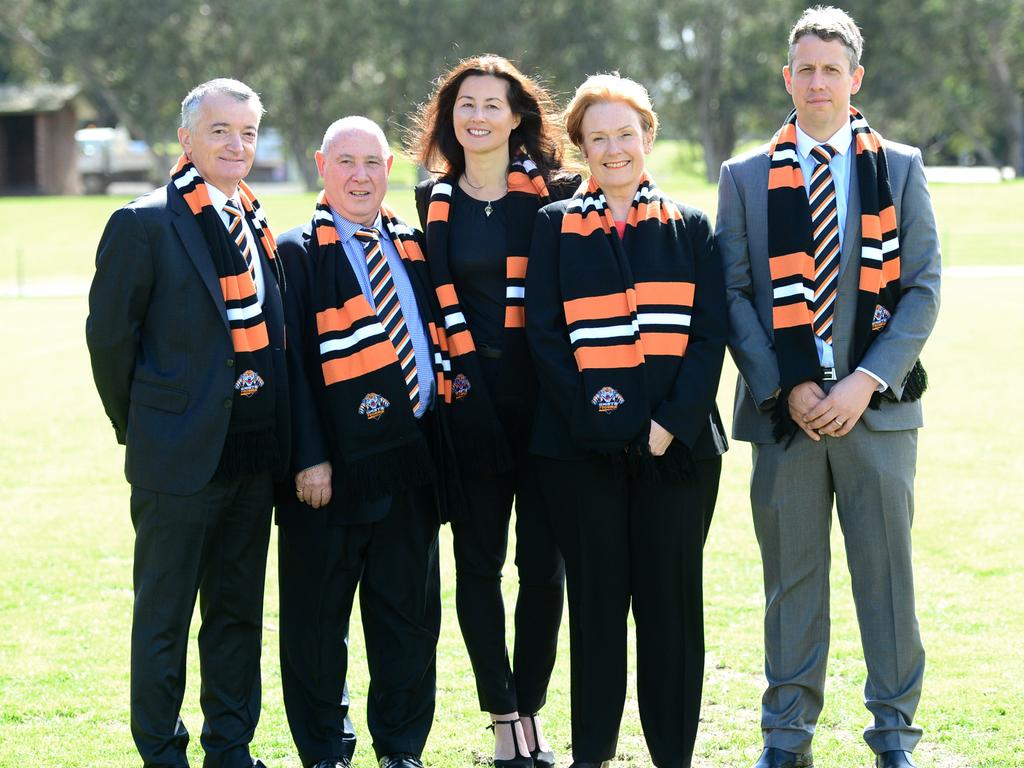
[85,183,290,496]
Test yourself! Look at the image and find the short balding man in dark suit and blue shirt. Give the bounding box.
[278,117,442,768]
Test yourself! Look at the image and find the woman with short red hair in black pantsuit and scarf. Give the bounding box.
[526,75,727,768]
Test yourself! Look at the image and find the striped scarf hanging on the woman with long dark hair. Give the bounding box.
[425,153,550,471]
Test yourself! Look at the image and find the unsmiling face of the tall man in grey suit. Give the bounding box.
[782,35,864,141]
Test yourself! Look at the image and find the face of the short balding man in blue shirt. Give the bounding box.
[316,128,394,226]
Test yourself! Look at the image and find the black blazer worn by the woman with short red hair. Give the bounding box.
[526,201,728,460]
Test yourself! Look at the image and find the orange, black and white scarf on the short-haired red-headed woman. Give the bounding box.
[559,174,695,457]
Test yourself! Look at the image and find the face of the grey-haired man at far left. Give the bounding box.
[178,92,260,197]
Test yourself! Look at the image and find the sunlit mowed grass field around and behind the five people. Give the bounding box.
[0,169,1024,768]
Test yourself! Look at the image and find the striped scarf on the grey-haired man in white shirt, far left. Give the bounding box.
[171,155,285,477]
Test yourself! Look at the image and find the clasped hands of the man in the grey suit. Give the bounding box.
[788,371,879,441]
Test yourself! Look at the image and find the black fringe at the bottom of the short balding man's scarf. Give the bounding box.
[337,439,436,501]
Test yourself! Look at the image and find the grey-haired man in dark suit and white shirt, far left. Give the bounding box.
[86,79,289,768]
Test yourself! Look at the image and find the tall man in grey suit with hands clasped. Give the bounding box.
[717,7,940,768]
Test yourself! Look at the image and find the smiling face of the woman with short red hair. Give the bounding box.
[580,101,653,198]
